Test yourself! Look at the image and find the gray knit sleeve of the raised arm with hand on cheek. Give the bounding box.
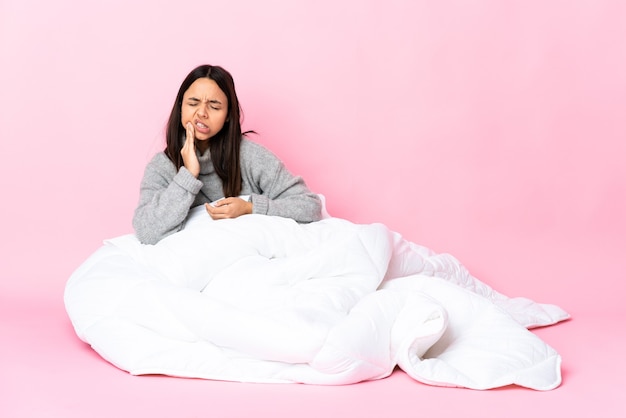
[133,153,202,244]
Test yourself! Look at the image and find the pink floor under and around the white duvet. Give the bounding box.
[0,294,626,418]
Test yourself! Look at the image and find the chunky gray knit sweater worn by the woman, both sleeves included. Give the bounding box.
[133,138,322,244]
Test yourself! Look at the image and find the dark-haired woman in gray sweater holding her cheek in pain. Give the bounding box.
[133,65,322,244]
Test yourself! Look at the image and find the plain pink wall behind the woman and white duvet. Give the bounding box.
[0,0,626,414]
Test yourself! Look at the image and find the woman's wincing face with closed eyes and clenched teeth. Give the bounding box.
[181,78,228,141]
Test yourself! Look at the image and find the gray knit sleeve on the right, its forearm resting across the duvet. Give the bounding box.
[242,141,322,223]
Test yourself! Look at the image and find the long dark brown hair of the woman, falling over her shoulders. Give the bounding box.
[164,65,246,197]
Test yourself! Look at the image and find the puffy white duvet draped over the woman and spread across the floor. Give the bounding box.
[65,204,568,390]
